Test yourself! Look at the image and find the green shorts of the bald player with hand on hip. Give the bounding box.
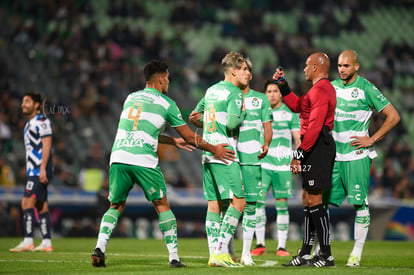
[324,157,371,206]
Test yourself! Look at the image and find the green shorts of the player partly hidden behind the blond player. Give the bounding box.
[240,165,262,202]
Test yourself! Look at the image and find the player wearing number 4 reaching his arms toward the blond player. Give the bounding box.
[91,60,234,268]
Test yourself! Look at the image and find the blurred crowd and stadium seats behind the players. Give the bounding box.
[0,0,414,237]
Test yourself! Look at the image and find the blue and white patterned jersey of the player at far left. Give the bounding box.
[24,113,53,178]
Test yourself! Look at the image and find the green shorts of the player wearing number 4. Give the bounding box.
[108,163,167,203]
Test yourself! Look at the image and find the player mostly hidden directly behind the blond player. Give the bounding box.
[237,59,272,265]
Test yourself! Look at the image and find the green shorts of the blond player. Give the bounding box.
[203,162,244,201]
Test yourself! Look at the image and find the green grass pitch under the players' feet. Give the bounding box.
[0,238,414,275]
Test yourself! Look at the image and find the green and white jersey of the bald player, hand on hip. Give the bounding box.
[331,76,390,161]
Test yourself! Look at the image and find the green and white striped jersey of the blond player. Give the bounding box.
[194,81,243,164]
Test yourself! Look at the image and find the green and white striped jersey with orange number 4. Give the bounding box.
[110,88,186,168]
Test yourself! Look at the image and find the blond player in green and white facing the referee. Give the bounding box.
[190,52,251,267]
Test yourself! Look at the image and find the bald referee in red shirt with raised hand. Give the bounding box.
[273,52,336,267]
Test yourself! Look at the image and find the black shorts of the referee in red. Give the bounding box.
[301,126,336,192]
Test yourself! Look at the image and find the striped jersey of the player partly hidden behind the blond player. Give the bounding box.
[237,89,273,165]
